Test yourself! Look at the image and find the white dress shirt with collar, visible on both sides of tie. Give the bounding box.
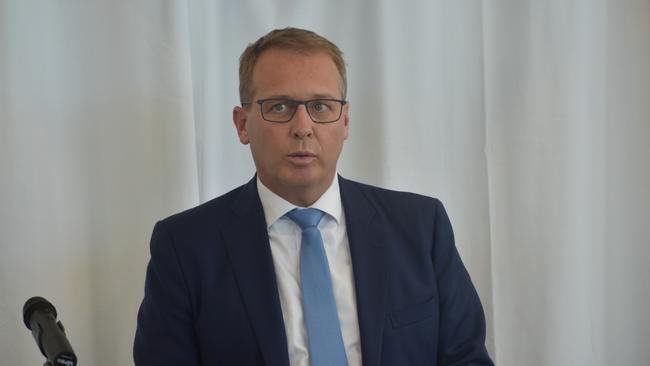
[257,175,361,366]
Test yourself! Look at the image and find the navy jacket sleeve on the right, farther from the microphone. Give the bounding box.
[432,200,494,366]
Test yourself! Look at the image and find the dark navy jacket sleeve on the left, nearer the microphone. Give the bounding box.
[133,222,199,366]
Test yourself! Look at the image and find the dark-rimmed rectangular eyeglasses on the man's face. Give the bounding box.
[242,99,347,123]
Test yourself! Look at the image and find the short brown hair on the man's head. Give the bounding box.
[239,28,348,103]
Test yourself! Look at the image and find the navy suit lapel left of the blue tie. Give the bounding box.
[223,178,289,365]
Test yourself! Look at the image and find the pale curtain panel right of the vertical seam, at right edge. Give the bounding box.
[483,1,650,365]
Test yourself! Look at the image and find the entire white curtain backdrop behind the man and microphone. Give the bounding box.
[0,0,650,366]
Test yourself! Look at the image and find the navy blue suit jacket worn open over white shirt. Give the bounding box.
[134,177,492,366]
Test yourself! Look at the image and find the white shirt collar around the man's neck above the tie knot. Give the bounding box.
[257,174,343,229]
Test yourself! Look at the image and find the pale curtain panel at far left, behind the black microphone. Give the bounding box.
[0,1,199,365]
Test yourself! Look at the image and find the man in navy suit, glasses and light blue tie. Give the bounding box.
[134,28,492,366]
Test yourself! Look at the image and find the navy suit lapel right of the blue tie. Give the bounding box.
[339,177,389,366]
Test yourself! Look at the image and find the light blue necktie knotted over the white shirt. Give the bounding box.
[286,208,348,366]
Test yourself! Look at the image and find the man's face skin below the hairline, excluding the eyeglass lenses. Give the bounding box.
[233,49,349,205]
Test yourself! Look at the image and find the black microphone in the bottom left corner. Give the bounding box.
[23,296,77,366]
